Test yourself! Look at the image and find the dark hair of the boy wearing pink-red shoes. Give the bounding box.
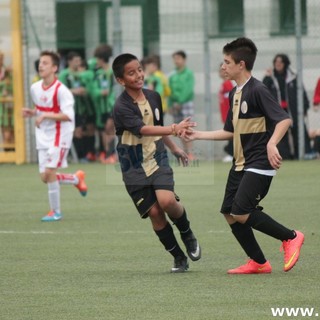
[223,38,258,71]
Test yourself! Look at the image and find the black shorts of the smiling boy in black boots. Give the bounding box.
[126,167,175,218]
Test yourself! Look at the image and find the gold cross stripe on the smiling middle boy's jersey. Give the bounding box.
[122,100,161,177]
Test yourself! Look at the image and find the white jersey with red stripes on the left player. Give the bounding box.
[30,79,75,149]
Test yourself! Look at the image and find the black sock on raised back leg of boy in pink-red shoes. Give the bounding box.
[245,210,295,241]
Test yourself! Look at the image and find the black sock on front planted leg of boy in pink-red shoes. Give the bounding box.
[230,222,267,264]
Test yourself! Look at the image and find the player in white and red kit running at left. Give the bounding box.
[22,51,87,222]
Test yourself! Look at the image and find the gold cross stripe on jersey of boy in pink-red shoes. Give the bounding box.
[232,91,267,171]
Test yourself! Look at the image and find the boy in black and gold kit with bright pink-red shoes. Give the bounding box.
[184,38,304,274]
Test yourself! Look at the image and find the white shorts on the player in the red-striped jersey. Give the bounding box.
[38,147,69,173]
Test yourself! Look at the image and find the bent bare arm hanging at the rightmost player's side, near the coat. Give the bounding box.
[267,119,292,169]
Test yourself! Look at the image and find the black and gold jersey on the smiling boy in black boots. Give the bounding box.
[113,89,169,184]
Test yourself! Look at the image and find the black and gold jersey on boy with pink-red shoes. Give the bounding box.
[224,77,289,171]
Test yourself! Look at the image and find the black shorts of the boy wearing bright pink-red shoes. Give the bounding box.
[220,170,273,215]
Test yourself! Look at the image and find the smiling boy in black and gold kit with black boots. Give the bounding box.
[112,54,201,272]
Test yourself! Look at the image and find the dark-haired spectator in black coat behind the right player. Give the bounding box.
[263,53,313,159]
